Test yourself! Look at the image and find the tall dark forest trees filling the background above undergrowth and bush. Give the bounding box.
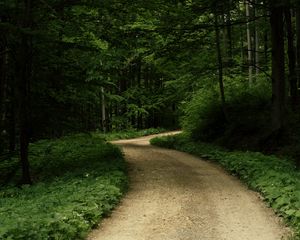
[0,0,300,183]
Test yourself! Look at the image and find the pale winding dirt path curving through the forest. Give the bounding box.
[88,132,287,240]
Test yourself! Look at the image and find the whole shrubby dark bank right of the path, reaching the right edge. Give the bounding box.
[181,78,300,165]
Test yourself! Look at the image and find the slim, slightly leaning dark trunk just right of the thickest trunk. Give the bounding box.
[284,8,297,108]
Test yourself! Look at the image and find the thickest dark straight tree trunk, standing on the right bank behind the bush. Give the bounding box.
[270,6,286,132]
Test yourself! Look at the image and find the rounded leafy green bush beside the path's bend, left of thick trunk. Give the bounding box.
[182,77,271,148]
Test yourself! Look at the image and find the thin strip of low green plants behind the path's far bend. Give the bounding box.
[94,128,167,141]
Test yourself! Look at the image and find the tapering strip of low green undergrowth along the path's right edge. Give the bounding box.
[151,134,300,239]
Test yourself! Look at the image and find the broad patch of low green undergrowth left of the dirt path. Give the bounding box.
[0,134,127,240]
